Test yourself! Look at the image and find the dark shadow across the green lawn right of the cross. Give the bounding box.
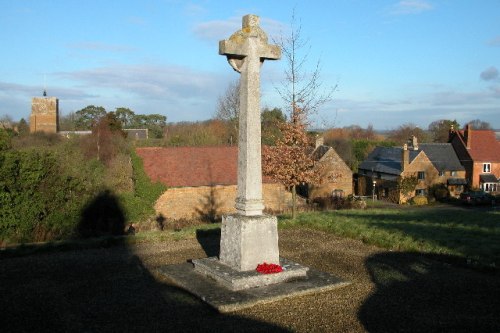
[336,207,500,266]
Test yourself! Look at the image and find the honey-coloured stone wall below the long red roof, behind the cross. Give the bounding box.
[155,184,298,221]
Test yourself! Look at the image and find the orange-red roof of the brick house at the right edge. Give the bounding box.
[460,130,500,162]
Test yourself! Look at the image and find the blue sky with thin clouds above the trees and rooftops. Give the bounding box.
[0,0,500,130]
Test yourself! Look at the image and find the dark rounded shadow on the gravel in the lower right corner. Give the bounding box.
[358,252,500,332]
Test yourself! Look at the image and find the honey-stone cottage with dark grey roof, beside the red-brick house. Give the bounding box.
[357,137,466,203]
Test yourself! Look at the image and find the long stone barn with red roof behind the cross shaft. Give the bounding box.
[136,146,296,221]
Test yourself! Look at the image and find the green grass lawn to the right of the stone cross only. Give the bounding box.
[280,206,500,267]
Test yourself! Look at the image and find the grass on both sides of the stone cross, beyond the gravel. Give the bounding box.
[0,205,500,267]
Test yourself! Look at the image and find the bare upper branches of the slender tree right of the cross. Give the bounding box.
[274,10,336,125]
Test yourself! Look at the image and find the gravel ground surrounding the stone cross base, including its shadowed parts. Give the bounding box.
[0,229,500,332]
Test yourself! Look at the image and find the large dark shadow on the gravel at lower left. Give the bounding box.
[0,231,287,332]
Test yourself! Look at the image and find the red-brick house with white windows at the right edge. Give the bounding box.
[449,125,500,193]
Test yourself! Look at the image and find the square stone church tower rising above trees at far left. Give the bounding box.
[30,90,59,133]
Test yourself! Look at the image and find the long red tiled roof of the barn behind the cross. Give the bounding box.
[136,146,276,187]
